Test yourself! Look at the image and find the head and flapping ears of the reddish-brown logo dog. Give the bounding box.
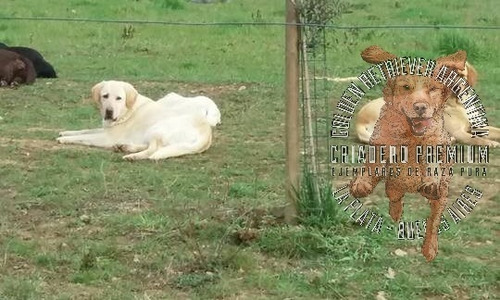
[361,46,466,136]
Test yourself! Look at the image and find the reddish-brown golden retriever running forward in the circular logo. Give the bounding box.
[350,46,466,261]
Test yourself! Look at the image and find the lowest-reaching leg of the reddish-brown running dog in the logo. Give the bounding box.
[422,197,446,261]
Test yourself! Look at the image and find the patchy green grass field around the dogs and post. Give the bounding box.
[0,0,500,300]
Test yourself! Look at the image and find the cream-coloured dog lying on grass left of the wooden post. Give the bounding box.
[57,81,220,160]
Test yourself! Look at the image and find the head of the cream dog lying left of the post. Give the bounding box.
[92,80,138,125]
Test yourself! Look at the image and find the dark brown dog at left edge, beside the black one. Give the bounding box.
[0,49,36,86]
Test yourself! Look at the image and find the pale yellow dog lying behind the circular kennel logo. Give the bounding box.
[355,61,500,147]
